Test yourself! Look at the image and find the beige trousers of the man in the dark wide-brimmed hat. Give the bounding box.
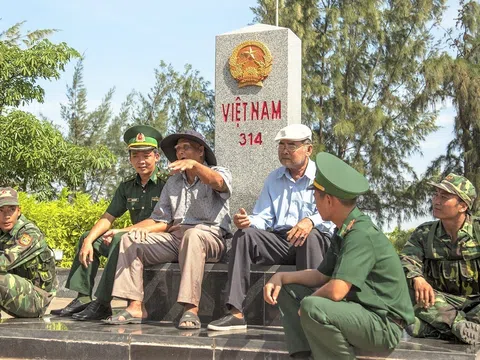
[112,224,225,306]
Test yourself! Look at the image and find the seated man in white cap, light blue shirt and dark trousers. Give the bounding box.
[208,124,334,331]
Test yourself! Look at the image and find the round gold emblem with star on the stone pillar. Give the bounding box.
[229,40,272,88]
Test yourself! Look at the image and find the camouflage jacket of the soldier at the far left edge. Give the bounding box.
[0,215,56,294]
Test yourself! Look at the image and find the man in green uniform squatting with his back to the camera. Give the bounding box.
[264,153,414,360]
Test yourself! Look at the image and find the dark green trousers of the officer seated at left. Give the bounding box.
[65,232,125,303]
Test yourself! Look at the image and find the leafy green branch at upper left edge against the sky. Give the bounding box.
[0,23,80,114]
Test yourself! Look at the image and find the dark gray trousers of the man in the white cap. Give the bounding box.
[225,227,330,311]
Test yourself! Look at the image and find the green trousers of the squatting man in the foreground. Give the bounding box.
[278,284,402,360]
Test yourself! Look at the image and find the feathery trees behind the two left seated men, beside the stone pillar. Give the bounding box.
[57,60,215,199]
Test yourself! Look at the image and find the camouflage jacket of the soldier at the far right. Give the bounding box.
[400,216,480,296]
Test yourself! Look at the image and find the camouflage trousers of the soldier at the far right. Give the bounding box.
[410,290,480,338]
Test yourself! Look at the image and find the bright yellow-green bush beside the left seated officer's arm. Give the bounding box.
[19,189,131,268]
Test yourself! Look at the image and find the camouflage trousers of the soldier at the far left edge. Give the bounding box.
[0,273,53,318]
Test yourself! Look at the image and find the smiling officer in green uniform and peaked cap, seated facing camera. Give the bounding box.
[51,125,164,320]
